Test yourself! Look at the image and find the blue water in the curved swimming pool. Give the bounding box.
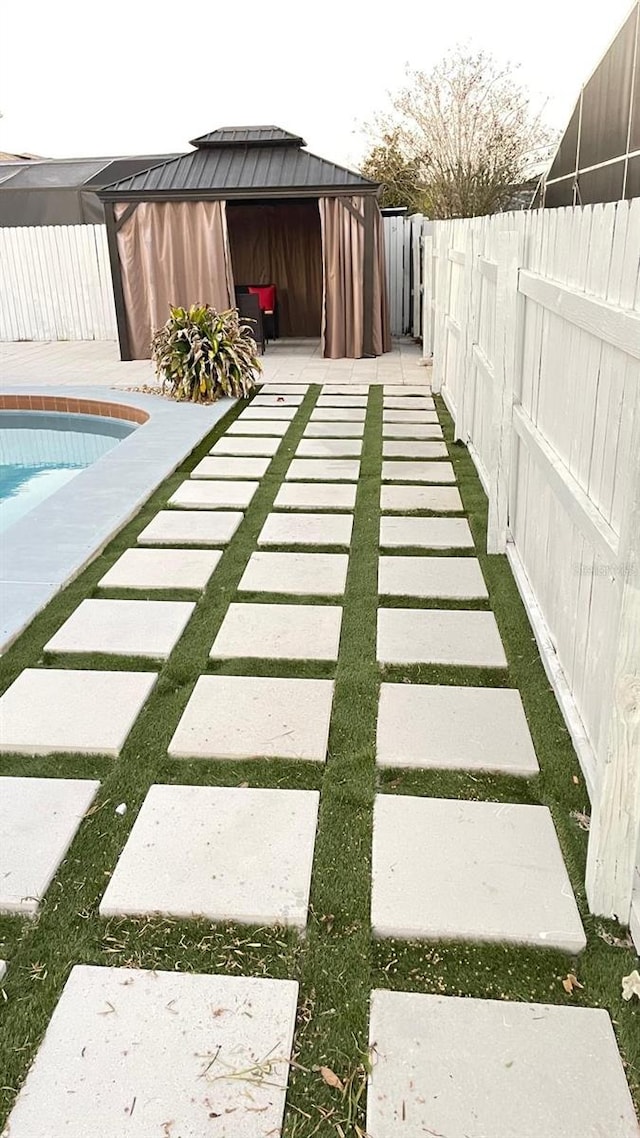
[0,411,136,533]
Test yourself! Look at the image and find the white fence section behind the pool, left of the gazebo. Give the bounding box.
[0,225,117,340]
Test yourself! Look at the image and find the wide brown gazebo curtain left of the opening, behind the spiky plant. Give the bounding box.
[115,201,235,360]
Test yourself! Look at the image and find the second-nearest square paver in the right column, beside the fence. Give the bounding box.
[371,794,586,954]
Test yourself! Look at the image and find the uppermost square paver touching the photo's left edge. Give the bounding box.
[0,668,157,758]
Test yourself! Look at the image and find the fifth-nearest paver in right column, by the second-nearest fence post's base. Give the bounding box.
[378,555,489,601]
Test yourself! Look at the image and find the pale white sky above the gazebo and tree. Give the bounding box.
[0,0,630,165]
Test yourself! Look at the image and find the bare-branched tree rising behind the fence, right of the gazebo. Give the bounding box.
[369,49,552,217]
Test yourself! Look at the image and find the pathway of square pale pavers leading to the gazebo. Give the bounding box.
[0,382,639,1138]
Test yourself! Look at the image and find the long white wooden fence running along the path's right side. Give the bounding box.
[422,200,640,942]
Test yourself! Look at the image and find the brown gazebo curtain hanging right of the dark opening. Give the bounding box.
[319,196,391,360]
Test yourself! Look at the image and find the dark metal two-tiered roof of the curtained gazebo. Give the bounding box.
[99,126,378,201]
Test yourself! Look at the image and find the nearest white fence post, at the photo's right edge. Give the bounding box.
[586,387,640,924]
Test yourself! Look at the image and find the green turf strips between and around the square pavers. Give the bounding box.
[0,387,640,1138]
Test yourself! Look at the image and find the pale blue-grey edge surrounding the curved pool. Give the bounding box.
[0,385,237,655]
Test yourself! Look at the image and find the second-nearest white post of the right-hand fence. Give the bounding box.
[486,230,523,553]
